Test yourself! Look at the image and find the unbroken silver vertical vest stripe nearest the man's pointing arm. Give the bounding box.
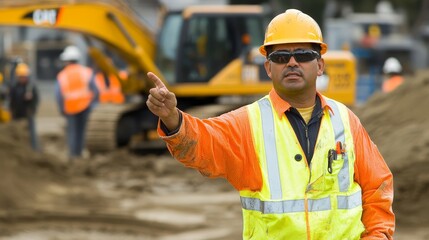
[258,98,282,199]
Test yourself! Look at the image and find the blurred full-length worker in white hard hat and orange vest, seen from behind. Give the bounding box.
[56,46,98,161]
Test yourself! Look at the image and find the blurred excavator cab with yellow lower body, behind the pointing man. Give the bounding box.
[155,5,271,98]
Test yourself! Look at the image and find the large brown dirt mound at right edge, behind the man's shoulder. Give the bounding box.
[355,71,429,223]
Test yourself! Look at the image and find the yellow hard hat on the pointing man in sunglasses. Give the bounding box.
[259,9,328,56]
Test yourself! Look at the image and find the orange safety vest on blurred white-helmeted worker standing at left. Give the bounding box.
[57,64,94,114]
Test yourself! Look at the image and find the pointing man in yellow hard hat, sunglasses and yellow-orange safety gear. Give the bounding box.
[146,9,395,239]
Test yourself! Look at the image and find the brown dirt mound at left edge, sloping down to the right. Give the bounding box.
[0,122,110,215]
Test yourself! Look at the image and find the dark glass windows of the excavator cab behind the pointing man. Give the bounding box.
[156,6,268,85]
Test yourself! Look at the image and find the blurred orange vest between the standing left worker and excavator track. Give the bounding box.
[95,73,125,103]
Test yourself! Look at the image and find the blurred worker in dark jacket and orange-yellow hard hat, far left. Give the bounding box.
[9,63,40,151]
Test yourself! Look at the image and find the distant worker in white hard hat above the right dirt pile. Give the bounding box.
[381,57,404,93]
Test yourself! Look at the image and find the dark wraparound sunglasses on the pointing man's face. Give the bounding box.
[268,49,320,63]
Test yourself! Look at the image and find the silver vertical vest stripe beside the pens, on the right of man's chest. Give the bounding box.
[327,99,350,192]
